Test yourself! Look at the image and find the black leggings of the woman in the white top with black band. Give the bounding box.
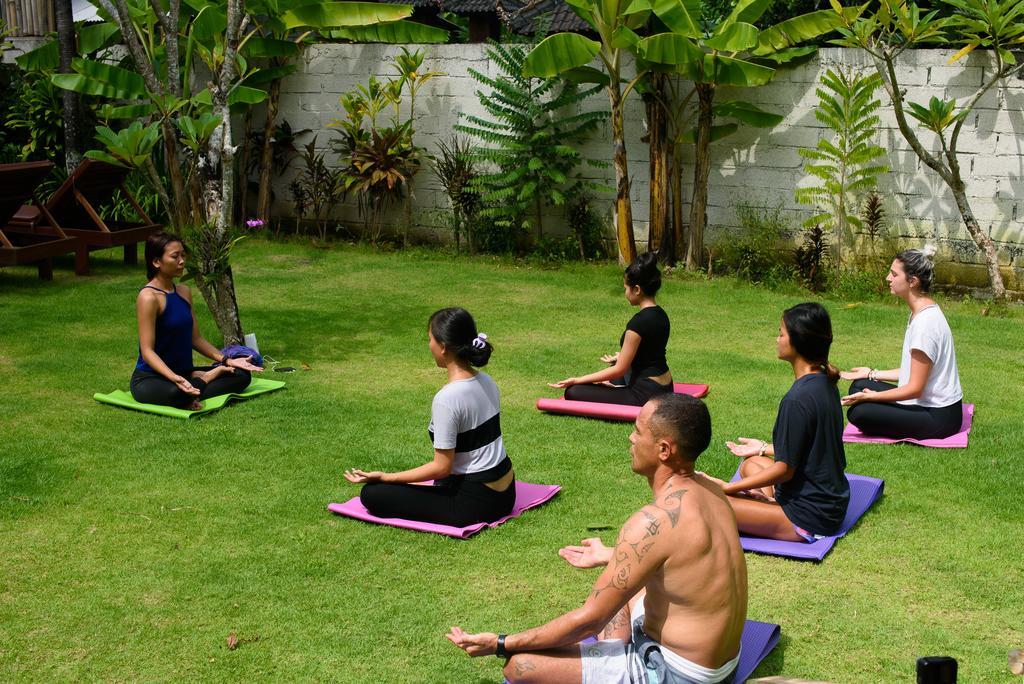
[359,475,515,527]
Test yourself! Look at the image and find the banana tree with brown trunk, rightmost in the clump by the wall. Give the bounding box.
[631,0,860,269]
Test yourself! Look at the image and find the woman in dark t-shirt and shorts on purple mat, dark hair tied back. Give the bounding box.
[722,302,850,542]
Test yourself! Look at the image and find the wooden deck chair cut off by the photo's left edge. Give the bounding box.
[0,162,80,281]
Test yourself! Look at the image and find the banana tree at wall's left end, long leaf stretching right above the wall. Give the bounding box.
[242,0,447,224]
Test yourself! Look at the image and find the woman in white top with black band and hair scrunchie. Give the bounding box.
[345,308,515,527]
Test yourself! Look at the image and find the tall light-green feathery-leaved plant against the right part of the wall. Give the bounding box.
[795,69,889,268]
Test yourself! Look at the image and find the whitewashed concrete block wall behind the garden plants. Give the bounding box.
[266,44,1024,289]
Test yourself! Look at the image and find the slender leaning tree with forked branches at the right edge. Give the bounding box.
[833,0,1024,300]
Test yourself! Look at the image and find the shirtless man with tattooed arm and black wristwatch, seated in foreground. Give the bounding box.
[447,394,746,684]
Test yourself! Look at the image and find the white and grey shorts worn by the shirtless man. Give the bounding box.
[580,600,739,684]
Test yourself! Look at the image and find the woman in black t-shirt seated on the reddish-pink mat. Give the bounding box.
[549,252,672,407]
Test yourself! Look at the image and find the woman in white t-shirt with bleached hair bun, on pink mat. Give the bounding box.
[842,246,964,439]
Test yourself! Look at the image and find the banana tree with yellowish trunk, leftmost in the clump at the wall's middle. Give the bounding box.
[523,0,650,263]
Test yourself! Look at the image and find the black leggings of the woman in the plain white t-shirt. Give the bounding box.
[846,380,964,439]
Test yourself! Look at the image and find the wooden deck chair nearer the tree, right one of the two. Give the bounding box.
[11,159,163,275]
